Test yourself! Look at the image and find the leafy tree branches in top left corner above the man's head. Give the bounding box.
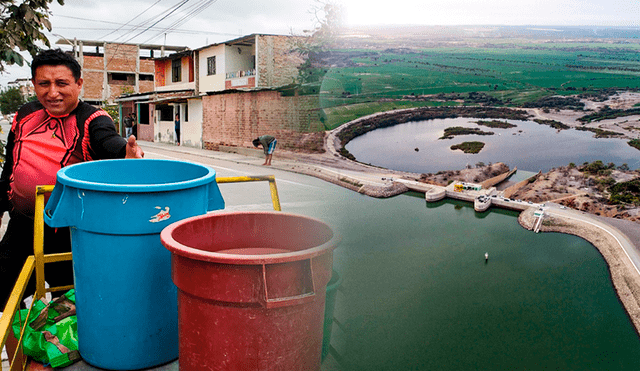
[0,0,64,72]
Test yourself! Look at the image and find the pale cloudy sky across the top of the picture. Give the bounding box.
[0,0,640,86]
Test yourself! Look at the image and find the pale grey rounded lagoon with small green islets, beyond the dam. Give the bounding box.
[346,118,640,173]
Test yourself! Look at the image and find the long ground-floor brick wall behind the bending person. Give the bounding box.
[202,90,322,150]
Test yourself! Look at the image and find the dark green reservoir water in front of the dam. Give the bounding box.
[221,173,640,371]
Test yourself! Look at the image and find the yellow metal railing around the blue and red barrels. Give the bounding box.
[0,175,282,371]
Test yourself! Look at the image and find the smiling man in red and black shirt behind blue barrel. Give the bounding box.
[0,49,144,308]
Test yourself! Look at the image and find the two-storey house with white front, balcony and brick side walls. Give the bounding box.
[116,34,319,149]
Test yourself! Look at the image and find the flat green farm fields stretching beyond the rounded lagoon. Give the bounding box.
[312,28,640,129]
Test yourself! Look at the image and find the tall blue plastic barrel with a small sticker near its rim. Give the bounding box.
[45,159,224,370]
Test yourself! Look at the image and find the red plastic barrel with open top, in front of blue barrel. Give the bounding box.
[160,212,340,371]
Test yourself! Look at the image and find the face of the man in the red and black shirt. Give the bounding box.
[31,66,82,116]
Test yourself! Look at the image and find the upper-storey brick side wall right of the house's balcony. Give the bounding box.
[256,35,304,87]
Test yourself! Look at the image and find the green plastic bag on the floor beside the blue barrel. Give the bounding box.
[12,290,80,367]
